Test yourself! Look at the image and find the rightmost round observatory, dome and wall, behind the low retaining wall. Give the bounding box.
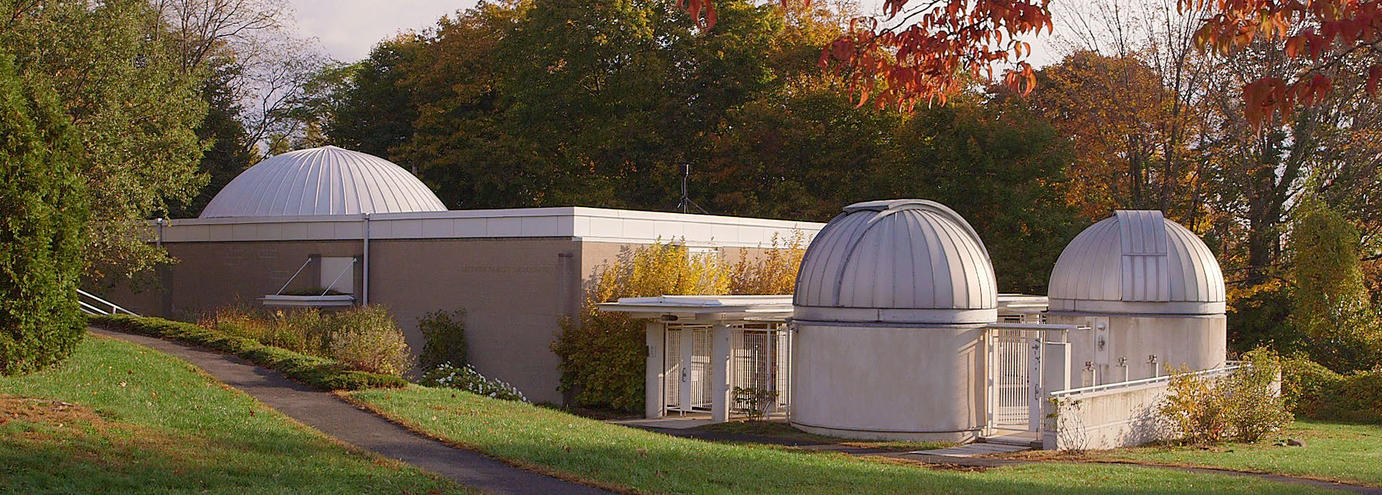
[1046,210,1227,386]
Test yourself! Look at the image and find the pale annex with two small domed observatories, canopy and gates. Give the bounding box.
[603,199,1236,449]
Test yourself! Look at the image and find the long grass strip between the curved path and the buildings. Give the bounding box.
[340,386,1337,494]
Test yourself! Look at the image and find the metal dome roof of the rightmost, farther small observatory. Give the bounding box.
[1048,210,1224,314]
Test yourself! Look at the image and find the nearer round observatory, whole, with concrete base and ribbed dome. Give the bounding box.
[789,199,998,441]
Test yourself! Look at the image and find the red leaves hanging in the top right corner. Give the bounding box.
[1180,0,1382,126]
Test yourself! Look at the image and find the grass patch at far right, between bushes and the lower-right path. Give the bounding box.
[1033,420,1382,487]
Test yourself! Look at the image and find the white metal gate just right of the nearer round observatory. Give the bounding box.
[988,328,1041,431]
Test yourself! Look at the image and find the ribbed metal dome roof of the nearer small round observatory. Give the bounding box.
[793,199,998,325]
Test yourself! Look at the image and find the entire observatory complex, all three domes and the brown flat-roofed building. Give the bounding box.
[102,147,1236,448]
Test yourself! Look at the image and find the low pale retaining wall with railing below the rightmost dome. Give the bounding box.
[1042,366,1238,451]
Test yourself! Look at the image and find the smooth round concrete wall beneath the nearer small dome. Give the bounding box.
[791,324,987,441]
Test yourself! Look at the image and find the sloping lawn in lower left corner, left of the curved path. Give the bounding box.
[0,336,464,495]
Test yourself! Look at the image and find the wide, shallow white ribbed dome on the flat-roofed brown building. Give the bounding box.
[202,147,446,218]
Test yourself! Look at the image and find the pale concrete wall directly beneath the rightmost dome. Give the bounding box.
[1048,312,1229,387]
